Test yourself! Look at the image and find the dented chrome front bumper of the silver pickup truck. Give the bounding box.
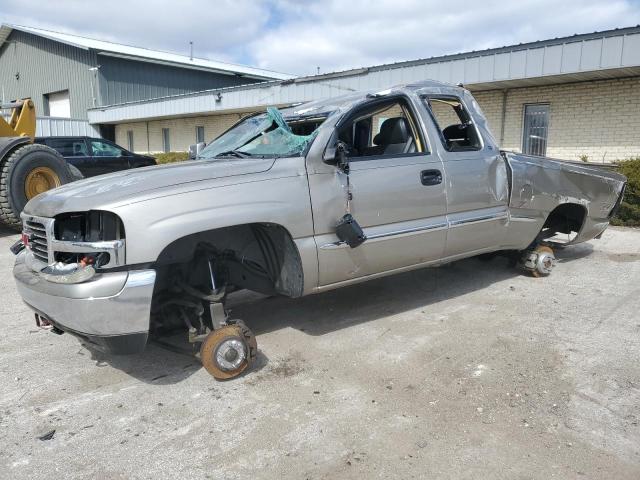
[13,251,156,354]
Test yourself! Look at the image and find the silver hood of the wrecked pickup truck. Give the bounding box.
[24,158,275,217]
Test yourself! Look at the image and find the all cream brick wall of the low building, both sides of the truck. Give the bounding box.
[116,77,640,162]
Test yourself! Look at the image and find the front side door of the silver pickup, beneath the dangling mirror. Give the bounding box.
[309,95,447,287]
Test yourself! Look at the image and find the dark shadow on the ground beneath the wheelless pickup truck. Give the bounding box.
[85,244,593,385]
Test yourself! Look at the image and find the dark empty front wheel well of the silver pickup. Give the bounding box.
[155,223,304,297]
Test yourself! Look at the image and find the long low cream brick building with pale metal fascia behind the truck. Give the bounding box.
[89,26,640,162]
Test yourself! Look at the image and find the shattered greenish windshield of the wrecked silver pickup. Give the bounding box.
[198,107,322,159]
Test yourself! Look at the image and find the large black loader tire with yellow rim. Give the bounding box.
[0,144,74,230]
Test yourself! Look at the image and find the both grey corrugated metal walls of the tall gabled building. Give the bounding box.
[0,30,257,122]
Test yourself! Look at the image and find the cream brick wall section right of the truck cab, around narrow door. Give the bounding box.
[474,77,640,162]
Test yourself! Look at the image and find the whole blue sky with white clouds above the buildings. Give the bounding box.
[0,0,640,75]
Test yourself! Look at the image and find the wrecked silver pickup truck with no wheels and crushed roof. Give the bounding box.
[14,82,626,378]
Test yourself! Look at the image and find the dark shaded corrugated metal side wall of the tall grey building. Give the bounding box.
[98,54,256,105]
